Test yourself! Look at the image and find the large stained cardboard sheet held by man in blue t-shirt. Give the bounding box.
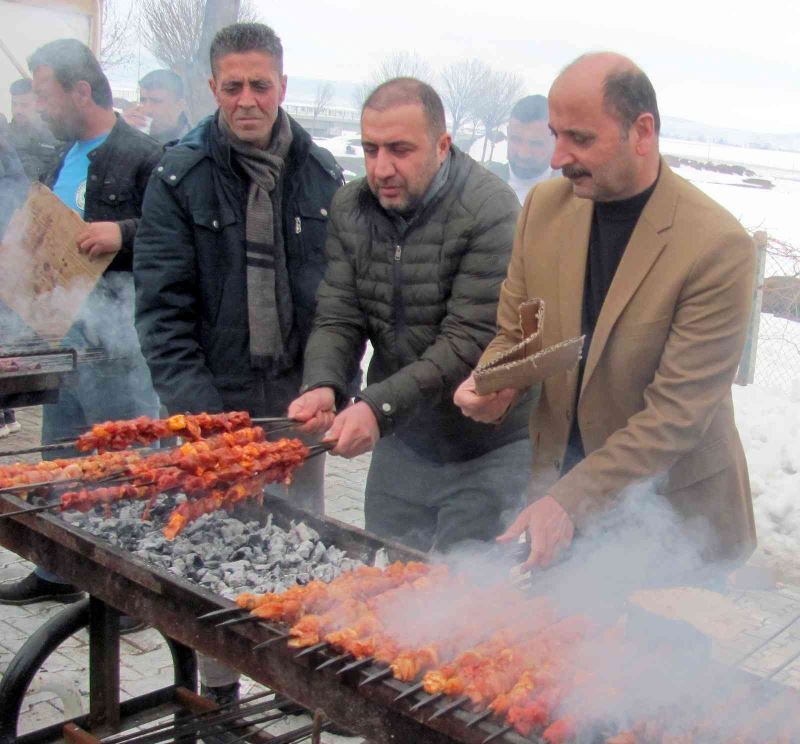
[0,183,114,341]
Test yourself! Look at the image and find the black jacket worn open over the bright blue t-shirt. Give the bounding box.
[42,116,162,271]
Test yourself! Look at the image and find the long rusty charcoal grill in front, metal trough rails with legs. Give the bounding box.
[0,494,552,744]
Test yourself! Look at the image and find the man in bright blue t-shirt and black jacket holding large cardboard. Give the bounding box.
[0,39,161,604]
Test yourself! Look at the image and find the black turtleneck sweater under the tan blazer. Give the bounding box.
[561,179,658,475]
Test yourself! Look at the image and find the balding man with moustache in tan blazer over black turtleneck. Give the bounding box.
[455,53,755,566]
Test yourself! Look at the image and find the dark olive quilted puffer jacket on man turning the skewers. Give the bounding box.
[303,148,529,462]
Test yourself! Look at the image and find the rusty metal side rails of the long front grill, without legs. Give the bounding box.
[0,494,532,744]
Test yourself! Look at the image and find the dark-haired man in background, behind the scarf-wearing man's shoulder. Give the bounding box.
[123,70,191,145]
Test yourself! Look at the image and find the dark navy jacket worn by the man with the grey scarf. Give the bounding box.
[134,110,343,415]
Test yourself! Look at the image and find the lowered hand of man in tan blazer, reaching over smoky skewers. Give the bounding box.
[497,496,575,571]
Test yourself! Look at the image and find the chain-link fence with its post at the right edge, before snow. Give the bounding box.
[737,231,800,399]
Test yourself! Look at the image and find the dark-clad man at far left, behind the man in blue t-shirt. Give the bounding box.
[8,78,56,181]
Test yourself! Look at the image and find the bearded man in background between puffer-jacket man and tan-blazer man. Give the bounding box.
[486,95,555,204]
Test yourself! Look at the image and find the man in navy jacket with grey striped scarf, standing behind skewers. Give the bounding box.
[134,24,343,524]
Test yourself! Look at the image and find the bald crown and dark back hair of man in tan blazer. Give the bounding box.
[553,52,661,134]
